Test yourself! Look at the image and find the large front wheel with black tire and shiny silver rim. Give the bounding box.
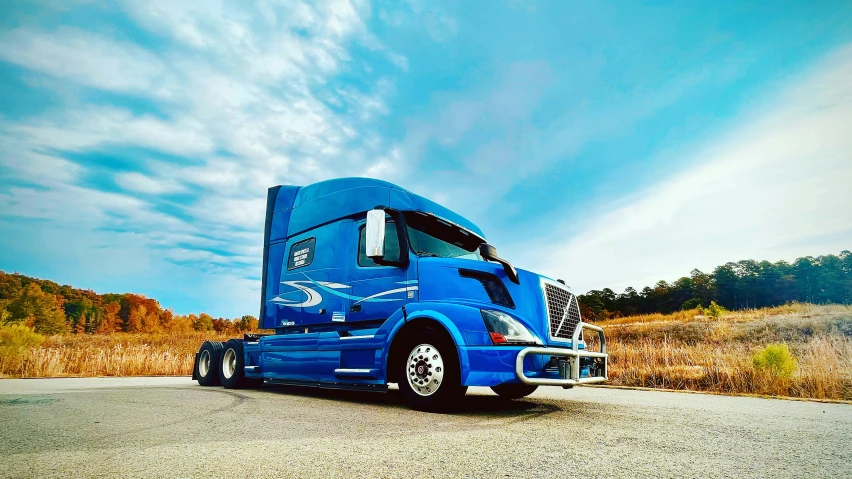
[395,329,467,412]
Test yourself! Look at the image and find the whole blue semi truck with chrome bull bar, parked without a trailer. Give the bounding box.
[193,178,607,411]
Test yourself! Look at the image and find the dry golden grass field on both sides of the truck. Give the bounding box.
[0,304,852,400]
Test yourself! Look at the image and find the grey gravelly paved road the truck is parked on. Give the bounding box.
[0,378,852,478]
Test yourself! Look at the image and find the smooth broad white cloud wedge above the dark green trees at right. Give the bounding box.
[525,46,852,291]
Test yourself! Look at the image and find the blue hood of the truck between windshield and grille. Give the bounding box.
[418,257,570,345]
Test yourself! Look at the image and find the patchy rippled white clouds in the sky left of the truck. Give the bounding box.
[0,0,406,314]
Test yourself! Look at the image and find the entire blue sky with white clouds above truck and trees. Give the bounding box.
[0,0,852,317]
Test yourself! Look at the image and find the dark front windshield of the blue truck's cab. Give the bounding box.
[405,212,483,260]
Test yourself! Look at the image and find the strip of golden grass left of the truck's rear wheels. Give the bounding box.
[0,332,233,378]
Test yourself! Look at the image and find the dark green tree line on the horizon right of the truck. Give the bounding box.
[578,250,852,320]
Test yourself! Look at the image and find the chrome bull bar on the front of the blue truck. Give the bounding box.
[515,322,609,386]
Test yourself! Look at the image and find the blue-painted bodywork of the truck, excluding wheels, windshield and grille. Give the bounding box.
[245,178,589,392]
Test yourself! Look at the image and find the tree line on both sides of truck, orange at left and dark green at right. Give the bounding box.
[0,250,852,334]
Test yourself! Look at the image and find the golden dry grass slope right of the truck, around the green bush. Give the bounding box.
[598,304,852,400]
